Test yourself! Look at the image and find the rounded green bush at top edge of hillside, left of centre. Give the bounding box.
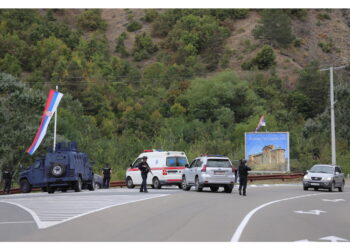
[78,9,107,31]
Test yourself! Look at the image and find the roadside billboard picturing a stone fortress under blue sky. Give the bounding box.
[245,132,290,172]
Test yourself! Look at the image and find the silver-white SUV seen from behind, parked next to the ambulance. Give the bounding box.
[182,155,235,193]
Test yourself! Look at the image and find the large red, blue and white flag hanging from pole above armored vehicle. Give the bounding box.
[27,89,63,155]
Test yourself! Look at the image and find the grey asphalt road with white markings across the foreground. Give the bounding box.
[0,185,350,242]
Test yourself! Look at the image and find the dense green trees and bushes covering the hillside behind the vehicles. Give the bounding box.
[0,9,350,179]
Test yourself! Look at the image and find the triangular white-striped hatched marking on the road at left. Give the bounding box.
[0,193,169,229]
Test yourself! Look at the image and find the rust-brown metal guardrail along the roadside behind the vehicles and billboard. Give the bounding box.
[0,173,304,195]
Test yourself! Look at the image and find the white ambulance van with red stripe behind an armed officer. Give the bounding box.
[125,149,188,189]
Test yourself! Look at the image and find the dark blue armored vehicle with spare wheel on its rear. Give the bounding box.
[19,142,95,193]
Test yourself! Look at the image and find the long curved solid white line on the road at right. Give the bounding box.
[231,192,348,242]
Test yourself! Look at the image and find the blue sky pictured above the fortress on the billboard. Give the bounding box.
[245,133,289,159]
